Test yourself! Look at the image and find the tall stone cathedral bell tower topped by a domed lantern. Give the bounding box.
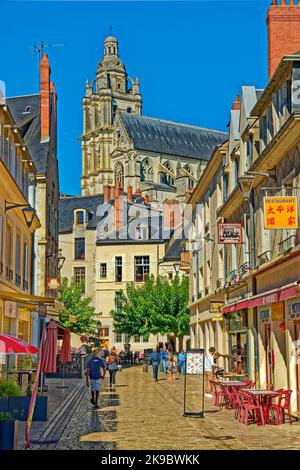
[80,36,142,196]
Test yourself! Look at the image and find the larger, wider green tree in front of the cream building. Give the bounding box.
[112,276,190,343]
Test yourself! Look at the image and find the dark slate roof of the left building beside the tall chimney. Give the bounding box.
[6,94,52,174]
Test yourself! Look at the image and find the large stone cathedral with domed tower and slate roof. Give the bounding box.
[80,36,227,201]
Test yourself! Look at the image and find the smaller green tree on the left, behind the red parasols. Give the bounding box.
[60,278,99,337]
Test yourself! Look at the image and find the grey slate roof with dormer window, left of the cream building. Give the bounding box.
[58,195,103,233]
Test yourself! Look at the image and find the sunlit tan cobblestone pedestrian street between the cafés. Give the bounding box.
[28,367,300,450]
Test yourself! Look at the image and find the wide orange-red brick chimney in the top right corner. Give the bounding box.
[266,0,300,80]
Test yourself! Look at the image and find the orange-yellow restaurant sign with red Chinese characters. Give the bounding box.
[264,196,298,230]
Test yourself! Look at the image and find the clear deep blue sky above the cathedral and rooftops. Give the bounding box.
[0,0,271,194]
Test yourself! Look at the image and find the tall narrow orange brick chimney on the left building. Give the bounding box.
[40,54,50,141]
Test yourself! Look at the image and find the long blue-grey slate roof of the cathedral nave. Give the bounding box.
[121,112,228,160]
